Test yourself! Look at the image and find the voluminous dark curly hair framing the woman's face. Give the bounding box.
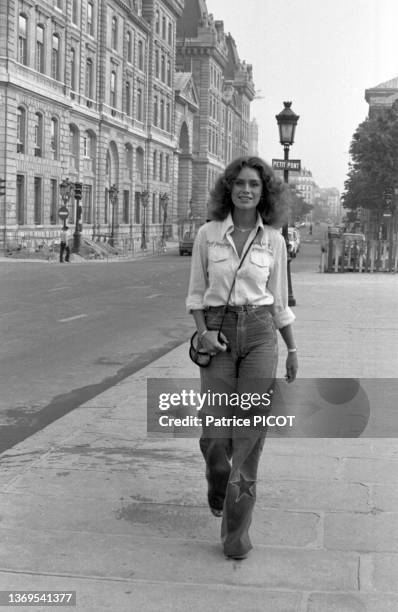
[208,156,289,227]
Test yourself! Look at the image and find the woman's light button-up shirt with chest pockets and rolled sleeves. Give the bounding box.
[186,214,296,329]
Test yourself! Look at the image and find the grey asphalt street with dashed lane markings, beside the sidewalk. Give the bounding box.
[0,237,319,451]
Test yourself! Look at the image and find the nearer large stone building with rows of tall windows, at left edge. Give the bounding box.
[0,0,184,248]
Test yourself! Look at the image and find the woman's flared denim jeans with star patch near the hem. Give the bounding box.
[200,306,278,556]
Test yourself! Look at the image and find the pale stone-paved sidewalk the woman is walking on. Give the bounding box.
[0,272,398,612]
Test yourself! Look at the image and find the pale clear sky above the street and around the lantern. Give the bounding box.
[206,0,398,192]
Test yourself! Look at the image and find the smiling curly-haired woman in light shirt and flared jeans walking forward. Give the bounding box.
[186,157,298,559]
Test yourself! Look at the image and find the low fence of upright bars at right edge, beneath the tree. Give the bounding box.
[320,238,398,273]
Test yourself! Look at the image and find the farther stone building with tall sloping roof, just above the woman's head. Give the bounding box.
[176,0,255,224]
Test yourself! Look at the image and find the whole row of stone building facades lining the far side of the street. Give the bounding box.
[0,0,254,251]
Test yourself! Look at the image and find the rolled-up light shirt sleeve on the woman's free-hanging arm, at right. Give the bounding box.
[267,232,296,329]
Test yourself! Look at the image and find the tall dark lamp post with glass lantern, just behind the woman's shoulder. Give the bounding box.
[275,102,299,306]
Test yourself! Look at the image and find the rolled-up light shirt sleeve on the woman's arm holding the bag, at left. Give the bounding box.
[185,226,208,313]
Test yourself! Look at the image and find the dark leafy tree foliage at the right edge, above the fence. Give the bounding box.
[343,103,398,209]
